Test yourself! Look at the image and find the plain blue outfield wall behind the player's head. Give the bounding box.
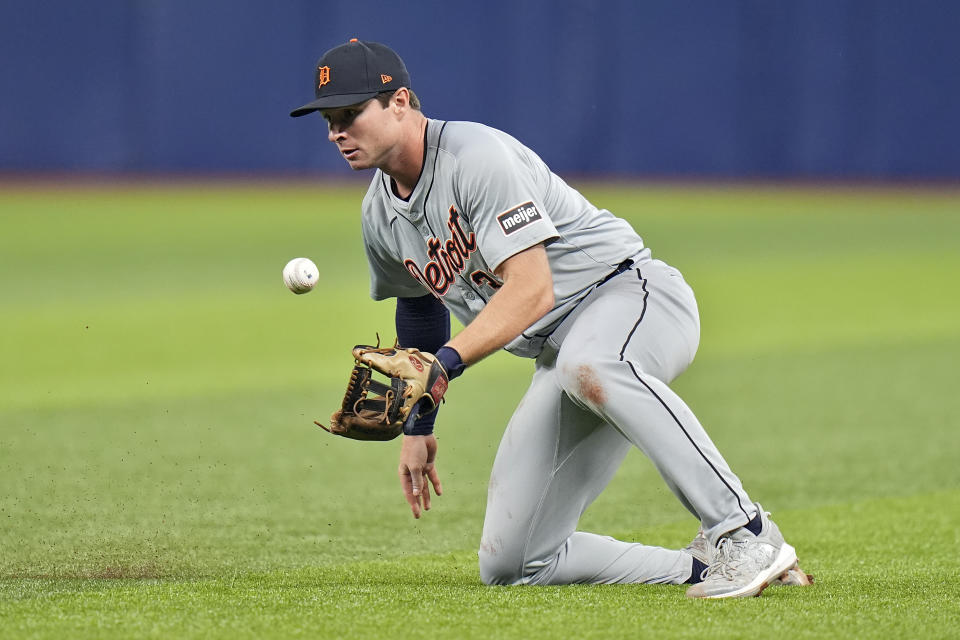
[0,0,960,178]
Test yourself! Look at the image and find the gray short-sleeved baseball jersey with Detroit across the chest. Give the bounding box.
[363,120,649,357]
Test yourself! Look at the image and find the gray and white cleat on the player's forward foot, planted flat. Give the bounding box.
[687,504,806,598]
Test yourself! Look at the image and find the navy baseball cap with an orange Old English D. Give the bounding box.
[290,38,410,118]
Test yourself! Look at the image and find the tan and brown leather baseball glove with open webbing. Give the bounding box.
[314,339,449,440]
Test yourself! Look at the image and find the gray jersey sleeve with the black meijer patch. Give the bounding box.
[456,135,558,270]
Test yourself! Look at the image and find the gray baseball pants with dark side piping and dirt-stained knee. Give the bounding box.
[479,260,756,584]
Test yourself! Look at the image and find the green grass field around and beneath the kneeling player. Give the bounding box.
[0,183,960,639]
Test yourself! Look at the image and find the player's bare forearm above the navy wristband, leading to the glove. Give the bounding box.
[447,271,554,365]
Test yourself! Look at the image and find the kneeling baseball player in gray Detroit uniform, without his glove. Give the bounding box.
[290,40,809,598]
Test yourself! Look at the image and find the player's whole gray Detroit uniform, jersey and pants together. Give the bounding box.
[363,120,757,584]
